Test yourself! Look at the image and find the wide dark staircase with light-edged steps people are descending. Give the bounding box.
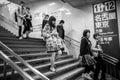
[0,26,84,80]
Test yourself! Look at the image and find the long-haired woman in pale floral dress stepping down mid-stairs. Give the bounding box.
[43,16,62,71]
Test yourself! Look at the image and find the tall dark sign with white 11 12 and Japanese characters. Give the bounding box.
[93,0,120,58]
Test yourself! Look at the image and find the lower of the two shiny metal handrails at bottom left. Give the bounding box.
[0,51,34,80]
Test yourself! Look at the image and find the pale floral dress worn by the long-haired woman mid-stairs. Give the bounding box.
[43,24,62,52]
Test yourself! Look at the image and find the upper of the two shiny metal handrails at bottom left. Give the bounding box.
[0,41,49,80]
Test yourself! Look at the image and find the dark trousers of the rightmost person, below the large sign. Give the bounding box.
[94,55,106,80]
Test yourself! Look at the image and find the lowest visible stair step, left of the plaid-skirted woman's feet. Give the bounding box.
[52,67,84,80]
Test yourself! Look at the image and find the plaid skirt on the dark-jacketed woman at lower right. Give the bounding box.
[82,54,96,66]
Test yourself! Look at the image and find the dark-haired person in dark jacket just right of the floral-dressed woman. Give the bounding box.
[57,20,65,40]
